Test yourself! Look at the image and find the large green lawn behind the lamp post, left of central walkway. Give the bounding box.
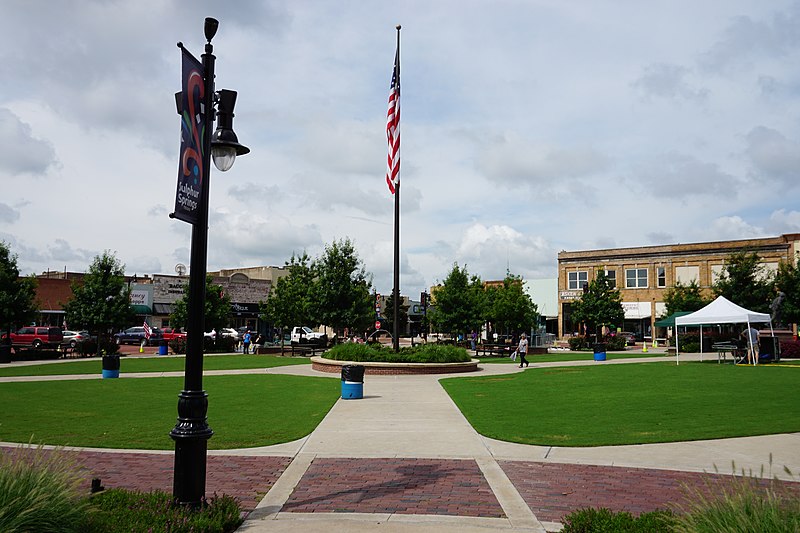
[0,374,341,450]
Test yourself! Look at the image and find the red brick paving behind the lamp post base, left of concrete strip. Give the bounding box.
[0,448,291,511]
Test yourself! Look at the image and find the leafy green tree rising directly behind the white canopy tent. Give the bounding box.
[714,251,774,313]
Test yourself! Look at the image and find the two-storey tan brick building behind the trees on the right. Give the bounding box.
[558,233,800,338]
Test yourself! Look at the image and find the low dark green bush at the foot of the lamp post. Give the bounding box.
[87,489,242,533]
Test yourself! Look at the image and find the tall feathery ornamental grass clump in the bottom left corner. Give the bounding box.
[0,446,89,533]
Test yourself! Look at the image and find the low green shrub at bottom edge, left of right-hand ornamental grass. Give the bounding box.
[561,508,675,533]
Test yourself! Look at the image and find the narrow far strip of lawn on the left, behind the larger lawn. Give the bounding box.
[0,355,309,377]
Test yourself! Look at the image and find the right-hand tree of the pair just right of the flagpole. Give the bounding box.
[487,273,539,336]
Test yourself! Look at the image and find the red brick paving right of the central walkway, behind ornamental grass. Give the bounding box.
[499,461,800,522]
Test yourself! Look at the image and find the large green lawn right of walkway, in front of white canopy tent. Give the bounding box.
[441,363,800,446]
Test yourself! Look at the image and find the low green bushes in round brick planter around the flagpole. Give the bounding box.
[325,342,470,363]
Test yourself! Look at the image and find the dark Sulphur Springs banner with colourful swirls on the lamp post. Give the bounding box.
[174,46,206,224]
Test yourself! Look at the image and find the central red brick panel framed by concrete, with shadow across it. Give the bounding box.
[282,458,505,518]
